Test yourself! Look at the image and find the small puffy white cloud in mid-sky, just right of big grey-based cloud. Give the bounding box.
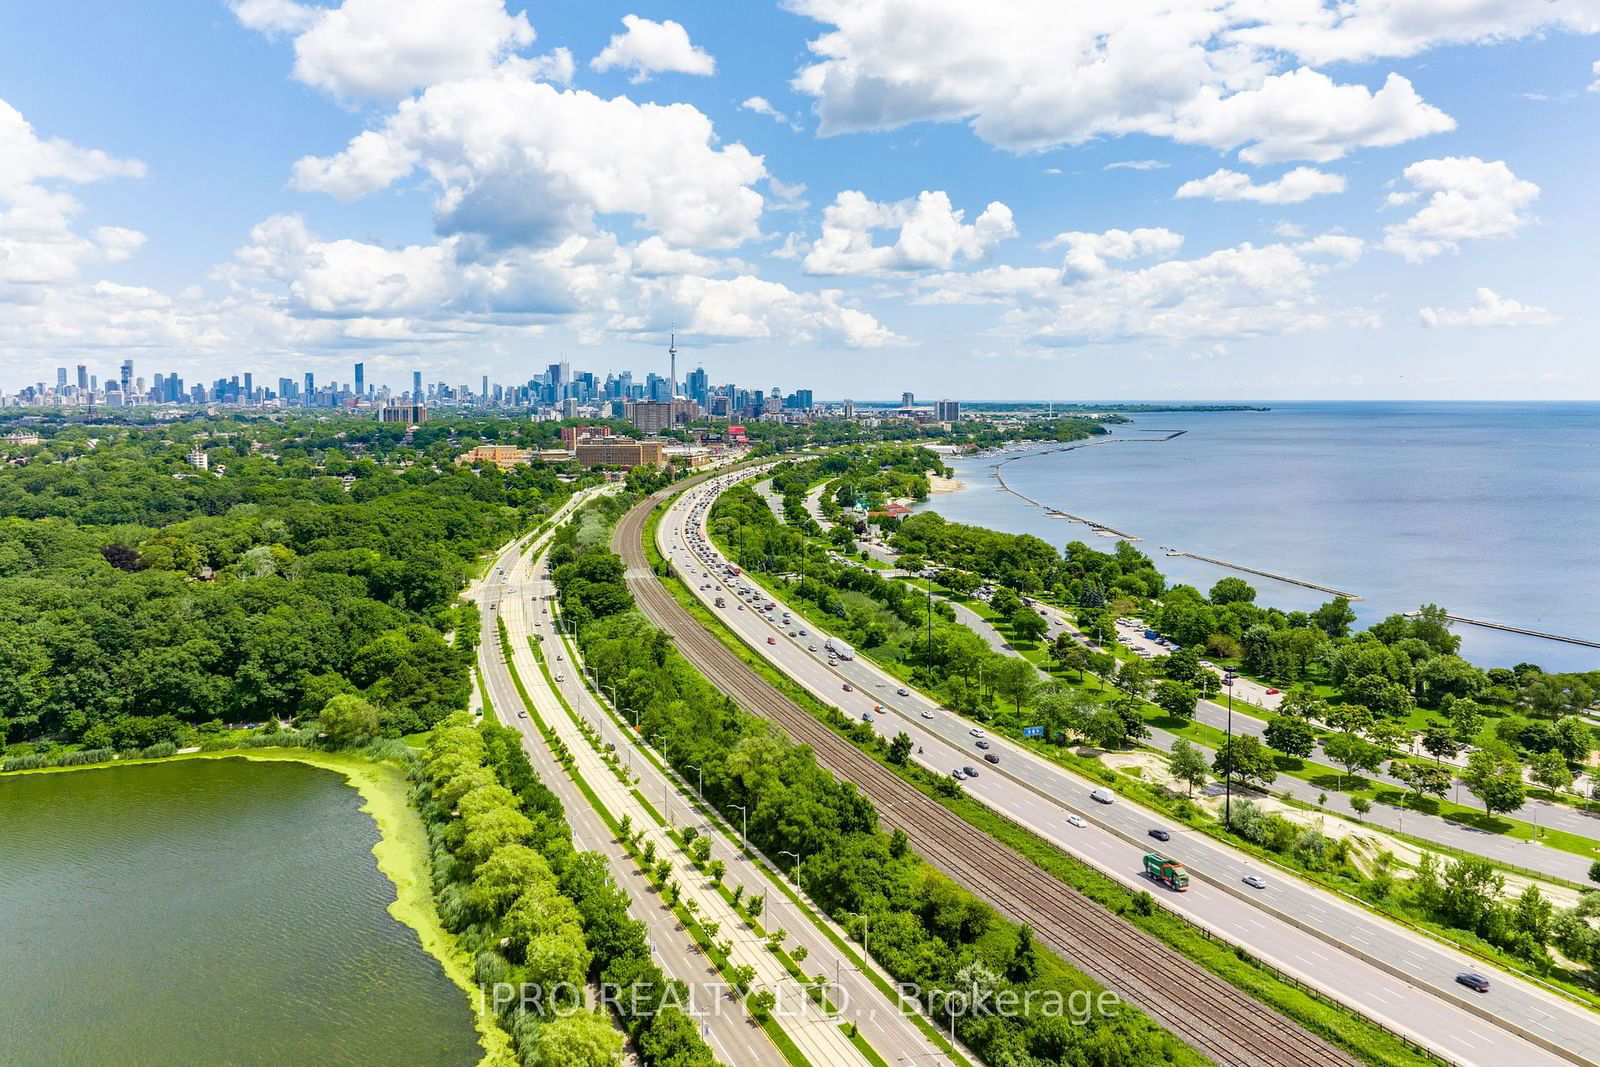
[802,190,1016,274]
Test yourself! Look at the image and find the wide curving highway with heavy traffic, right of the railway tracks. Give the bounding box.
[658,478,1600,1064]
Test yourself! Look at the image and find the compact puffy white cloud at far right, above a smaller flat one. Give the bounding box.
[1382,155,1539,262]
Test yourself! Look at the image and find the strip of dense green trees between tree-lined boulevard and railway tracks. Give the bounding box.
[552,543,1200,1064]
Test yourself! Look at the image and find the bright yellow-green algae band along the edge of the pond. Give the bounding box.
[0,747,512,1067]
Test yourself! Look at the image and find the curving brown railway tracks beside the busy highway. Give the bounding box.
[611,475,1362,1067]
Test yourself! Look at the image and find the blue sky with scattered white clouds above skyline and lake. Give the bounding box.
[0,0,1600,400]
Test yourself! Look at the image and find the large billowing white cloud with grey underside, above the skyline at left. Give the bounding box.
[294,69,766,248]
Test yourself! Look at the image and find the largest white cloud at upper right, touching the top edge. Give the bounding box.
[789,0,1465,163]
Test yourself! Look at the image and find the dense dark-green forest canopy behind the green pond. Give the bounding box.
[0,418,588,749]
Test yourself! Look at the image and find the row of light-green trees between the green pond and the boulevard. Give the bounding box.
[413,715,715,1067]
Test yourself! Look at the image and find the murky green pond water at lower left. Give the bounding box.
[0,760,482,1065]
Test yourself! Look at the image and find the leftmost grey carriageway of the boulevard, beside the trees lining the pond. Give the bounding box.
[469,493,782,1067]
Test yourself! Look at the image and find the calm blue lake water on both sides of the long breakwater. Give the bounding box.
[926,403,1600,670]
